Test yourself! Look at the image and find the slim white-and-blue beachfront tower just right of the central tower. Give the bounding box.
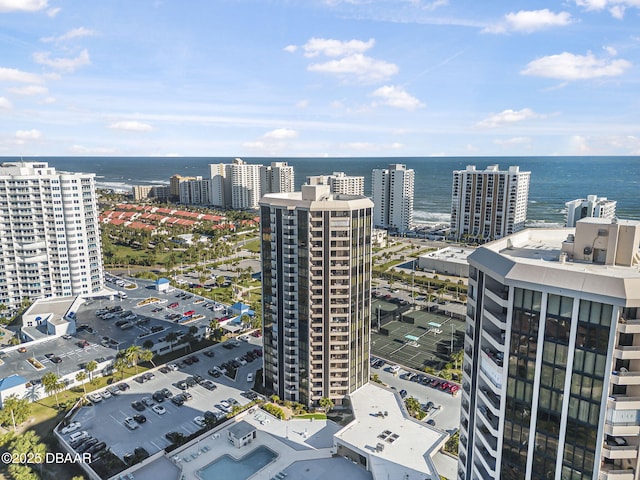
[372,164,415,233]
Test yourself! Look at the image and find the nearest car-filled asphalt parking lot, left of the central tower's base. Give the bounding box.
[64,338,262,458]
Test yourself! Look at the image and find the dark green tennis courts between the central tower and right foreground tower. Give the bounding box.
[371,310,465,370]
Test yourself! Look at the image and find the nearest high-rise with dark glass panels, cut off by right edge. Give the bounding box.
[458,218,640,480]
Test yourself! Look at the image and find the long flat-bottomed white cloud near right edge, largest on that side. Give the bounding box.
[520,52,631,80]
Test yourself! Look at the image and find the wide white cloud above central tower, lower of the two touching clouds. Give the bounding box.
[307,53,399,83]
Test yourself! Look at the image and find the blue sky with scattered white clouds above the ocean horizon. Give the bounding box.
[0,0,640,157]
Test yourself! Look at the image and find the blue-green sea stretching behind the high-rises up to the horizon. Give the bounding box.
[6,157,640,225]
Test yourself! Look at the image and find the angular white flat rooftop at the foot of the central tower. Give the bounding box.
[335,383,449,480]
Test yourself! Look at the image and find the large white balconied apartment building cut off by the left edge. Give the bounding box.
[0,162,104,312]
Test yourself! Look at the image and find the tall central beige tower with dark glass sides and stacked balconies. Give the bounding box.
[260,185,373,406]
